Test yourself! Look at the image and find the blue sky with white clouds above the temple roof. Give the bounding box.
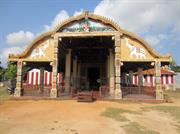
[0,0,180,67]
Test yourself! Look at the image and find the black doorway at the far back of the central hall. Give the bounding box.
[88,67,100,90]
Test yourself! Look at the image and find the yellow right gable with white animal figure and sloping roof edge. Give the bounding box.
[121,36,172,62]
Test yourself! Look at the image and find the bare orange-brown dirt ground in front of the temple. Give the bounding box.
[0,100,180,134]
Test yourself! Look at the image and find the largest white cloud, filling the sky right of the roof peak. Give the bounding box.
[94,0,180,33]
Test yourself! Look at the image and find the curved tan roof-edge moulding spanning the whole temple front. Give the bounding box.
[9,11,172,61]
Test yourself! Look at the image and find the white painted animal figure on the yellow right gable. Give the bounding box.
[126,39,146,59]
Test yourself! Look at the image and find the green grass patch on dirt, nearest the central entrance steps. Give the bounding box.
[101,107,138,122]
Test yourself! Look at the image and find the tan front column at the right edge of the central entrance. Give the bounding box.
[114,34,122,99]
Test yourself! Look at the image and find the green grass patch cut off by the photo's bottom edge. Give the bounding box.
[122,122,159,134]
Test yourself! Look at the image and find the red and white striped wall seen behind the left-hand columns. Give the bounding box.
[26,69,62,86]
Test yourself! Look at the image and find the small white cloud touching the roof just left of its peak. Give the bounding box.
[44,10,69,31]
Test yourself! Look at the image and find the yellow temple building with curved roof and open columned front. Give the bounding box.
[9,12,172,100]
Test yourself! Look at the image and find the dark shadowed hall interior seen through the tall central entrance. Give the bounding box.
[58,35,114,91]
